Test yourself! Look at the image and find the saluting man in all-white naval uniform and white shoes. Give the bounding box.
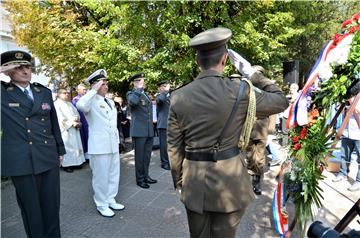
[77,69,125,217]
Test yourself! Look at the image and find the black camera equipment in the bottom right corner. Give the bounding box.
[307,221,360,238]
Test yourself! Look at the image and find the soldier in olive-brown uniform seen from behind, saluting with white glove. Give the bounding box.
[168,28,288,237]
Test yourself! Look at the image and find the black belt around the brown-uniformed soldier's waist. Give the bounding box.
[185,147,240,162]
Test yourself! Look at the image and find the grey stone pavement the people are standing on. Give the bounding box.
[1,150,360,238]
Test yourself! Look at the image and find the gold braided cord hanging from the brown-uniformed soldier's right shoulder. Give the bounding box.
[238,79,256,150]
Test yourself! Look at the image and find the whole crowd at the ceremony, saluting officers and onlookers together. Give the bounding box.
[1,28,360,237]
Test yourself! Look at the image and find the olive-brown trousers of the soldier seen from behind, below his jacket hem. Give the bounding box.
[186,209,245,238]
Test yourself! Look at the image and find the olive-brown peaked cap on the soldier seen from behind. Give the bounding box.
[189,27,232,56]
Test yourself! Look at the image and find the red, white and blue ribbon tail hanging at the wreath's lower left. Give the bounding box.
[272,164,288,237]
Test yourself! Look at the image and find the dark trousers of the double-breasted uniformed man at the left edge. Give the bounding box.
[11,167,60,238]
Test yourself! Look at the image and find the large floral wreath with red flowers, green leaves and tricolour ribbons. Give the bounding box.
[273,13,360,236]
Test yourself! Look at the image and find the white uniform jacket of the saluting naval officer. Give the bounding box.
[76,89,120,154]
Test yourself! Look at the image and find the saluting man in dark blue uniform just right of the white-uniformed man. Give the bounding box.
[126,73,157,189]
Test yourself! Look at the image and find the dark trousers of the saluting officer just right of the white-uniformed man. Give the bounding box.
[133,137,153,183]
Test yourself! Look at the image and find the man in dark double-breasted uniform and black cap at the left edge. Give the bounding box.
[1,50,65,237]
